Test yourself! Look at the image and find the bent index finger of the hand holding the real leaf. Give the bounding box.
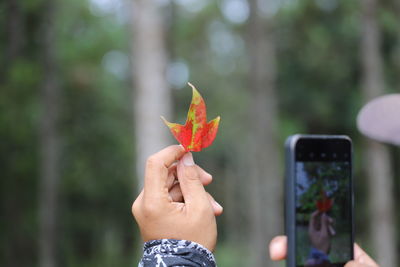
[144,145,185,198]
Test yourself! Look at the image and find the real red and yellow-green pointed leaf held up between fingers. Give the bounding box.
[161,83,220,152]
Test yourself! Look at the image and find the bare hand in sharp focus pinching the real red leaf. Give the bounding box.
[132,145,222,251]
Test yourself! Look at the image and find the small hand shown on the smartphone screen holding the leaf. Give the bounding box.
[308,211,334,254]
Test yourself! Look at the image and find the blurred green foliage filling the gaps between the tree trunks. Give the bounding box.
[0,0,400,266]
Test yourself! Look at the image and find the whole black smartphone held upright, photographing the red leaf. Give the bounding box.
[285,134,354,267]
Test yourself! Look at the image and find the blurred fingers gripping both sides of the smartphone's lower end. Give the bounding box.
[269,235,379,267]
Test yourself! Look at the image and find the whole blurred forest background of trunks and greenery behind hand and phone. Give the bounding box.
[0,0,400,267]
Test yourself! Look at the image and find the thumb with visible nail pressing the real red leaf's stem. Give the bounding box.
[177,152,209,208]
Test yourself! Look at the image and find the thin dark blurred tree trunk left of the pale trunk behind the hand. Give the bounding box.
[39,0,60,267]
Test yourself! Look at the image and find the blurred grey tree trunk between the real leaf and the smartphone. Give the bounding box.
[247,0,283,267]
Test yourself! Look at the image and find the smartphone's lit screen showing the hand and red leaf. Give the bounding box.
[295,141,353,267]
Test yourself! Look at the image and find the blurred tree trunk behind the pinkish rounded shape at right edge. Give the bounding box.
[361,0,398,267]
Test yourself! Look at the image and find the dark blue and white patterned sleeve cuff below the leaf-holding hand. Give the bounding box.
[139,239,216,267]
